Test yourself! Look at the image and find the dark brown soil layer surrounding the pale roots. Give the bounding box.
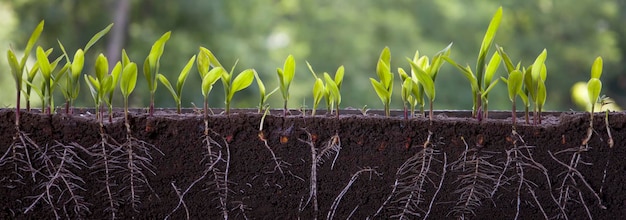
[0,109,626,219]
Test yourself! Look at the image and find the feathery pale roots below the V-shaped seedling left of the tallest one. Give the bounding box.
[372,132,447,219]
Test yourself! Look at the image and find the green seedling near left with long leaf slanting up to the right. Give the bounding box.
[57,24,113,114]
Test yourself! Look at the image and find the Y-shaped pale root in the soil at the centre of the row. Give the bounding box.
[298,130,341,219]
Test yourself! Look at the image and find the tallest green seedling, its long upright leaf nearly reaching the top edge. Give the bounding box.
[444,7,502,120]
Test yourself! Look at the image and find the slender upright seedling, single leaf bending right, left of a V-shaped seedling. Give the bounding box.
[143,31,171,116]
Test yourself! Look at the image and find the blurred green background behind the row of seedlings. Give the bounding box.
[0,0,626,111]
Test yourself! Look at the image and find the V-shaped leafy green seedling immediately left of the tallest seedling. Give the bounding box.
[407,43,452,122]
